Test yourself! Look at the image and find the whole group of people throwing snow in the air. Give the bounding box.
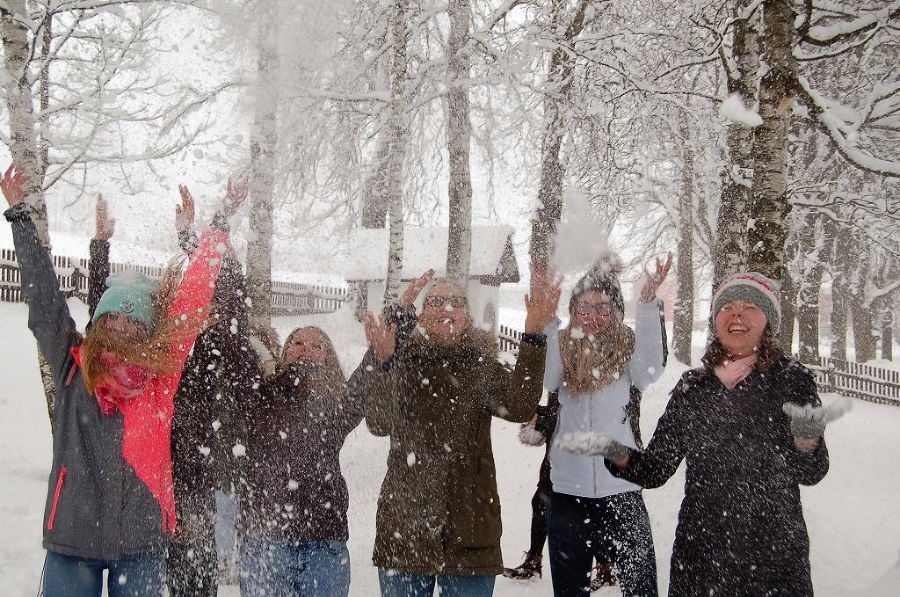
[0,159,840,597]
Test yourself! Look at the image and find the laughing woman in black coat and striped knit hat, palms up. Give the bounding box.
[565,273,837,597]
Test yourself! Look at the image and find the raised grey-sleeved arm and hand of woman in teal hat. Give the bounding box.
[0,166,80,379]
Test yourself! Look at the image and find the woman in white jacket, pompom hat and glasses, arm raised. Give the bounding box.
[544,253,672,597]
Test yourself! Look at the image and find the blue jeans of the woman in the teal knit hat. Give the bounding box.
[43,551,166,597]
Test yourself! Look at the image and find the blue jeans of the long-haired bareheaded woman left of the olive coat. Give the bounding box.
[240,536,350,597]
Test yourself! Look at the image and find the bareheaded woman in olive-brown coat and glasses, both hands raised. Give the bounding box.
[366,272,559,597]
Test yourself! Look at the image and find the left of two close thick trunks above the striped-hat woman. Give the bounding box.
[713,0,759,290]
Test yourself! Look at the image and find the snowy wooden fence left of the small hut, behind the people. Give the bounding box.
[0,249,349,315]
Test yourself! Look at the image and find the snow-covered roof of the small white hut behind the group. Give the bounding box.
[342,226,518,282]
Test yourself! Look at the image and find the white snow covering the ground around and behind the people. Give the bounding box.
[0,300,900,597]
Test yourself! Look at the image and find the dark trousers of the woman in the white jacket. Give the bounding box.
[547,491,658,597]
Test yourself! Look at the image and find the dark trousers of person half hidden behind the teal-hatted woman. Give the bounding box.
[166,490,219,597]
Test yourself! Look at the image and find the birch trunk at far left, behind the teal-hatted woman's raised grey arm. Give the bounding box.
[0,0,56,433]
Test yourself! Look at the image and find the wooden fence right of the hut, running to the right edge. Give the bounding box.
[500,325,900,406]
